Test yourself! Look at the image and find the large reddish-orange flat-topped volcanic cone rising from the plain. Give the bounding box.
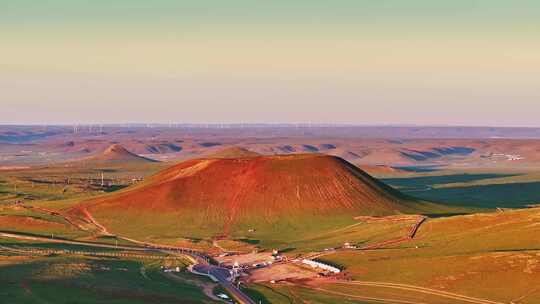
[72,154,426,233]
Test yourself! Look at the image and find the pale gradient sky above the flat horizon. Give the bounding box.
[0,0,540,126]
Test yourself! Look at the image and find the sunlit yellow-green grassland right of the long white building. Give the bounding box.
[312,208,540,303]
